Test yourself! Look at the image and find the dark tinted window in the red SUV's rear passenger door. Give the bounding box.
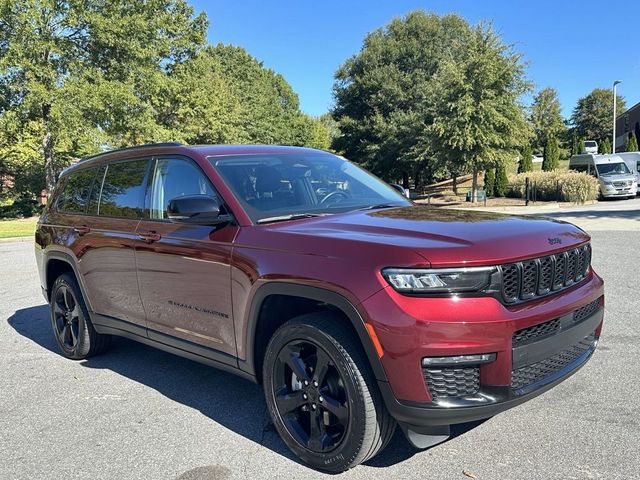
[98,160,148,218]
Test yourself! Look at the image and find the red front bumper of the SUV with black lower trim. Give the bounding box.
[365,271,604,430]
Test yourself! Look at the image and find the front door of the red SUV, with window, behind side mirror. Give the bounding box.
[136,157,237,363]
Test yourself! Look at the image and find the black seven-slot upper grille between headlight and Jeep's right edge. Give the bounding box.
[500,244,591,303]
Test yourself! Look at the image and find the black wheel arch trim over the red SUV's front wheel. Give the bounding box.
[238,281,387,382]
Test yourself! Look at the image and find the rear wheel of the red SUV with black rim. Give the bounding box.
[49,273,111,360]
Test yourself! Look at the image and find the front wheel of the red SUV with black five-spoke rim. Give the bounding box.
[263,312,396,473]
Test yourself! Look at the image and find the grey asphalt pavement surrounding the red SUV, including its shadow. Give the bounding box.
[0,199,640,480]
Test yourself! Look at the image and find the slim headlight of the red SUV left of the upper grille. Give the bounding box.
[382,267,497,293]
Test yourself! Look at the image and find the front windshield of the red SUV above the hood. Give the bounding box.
[208,153,411,222]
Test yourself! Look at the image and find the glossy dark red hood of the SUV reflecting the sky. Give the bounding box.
[273,205,589,266]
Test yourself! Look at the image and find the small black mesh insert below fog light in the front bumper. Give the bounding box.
[422,366,480,400]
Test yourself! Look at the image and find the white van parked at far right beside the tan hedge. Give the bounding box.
[569,153,638,198]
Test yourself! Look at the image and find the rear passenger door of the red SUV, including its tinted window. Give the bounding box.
[78,158,150,335]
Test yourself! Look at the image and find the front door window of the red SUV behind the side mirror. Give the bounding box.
[150,158,217,220]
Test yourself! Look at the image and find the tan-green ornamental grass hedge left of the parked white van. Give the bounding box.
[509,170,598,203]
